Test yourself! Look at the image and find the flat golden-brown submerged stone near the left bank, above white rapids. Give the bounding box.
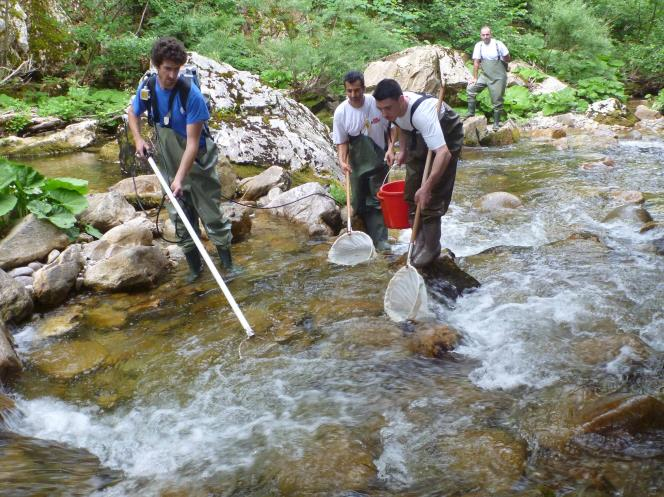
[30,340,108,380]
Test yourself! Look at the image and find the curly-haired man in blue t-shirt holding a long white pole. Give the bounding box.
[128,37,232,281]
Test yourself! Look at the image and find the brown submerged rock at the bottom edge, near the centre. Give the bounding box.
[275,425,377,495]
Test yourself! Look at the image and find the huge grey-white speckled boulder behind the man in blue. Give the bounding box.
[188,52,342,178]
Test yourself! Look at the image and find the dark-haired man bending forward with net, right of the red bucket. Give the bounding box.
[373,79,463,267]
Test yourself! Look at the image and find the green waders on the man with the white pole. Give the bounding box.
[157,126,231,254]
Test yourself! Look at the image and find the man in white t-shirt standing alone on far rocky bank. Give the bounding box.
[467,26,510,130]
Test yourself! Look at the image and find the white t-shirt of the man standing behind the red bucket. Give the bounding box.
[332,95,388,149]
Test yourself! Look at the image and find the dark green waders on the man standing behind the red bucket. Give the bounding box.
[348,135,389,246]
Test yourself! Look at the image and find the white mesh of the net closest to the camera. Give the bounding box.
[383,266,435,322]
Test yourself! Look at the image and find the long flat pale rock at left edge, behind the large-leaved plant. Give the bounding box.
[0,119,97,157]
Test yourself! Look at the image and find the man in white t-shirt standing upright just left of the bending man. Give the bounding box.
[332,71,389,251]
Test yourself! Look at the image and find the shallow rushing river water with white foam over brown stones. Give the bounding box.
[0,134,664,497]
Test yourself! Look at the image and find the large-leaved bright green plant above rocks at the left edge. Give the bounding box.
[0,158,94,236]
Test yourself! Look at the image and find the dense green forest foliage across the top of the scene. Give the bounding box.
[0,0,664,100]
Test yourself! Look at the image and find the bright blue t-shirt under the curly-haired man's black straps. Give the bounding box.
[132,78,210,147]
